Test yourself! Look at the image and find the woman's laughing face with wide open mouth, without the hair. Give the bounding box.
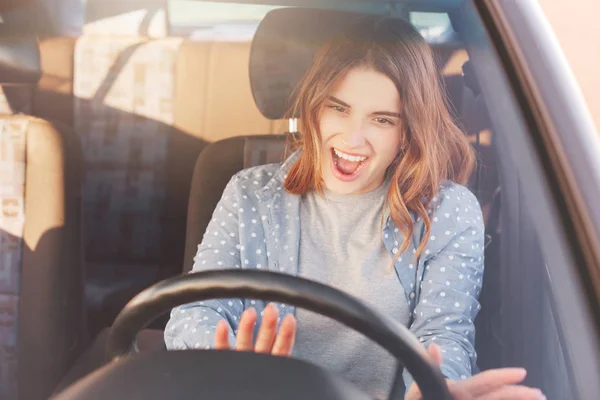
[319,68,403,194]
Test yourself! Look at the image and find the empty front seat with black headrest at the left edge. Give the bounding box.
[0,37,87,400]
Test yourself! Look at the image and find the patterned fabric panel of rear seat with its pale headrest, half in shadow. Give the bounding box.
[73,1,182,269]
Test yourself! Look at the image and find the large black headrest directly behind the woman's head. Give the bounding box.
[250,8,390,119]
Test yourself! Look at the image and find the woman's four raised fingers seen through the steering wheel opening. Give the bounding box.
[215,303,296,357]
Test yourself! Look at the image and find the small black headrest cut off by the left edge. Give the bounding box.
[0,36,42,85]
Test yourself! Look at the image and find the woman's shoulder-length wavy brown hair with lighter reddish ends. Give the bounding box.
[284,17,475,262]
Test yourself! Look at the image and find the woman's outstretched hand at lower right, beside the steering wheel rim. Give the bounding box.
[404,344,546,400]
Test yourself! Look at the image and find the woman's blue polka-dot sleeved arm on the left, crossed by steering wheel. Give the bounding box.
[164,175,244,350]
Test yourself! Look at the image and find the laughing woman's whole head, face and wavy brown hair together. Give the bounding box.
[285,20,475,255]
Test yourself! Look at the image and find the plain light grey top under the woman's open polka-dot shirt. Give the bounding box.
[293,182,410,398]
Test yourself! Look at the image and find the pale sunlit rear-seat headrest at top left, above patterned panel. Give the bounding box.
[83,0,169,38]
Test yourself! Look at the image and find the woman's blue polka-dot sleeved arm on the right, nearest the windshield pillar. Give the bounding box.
[404,187,484,388]
